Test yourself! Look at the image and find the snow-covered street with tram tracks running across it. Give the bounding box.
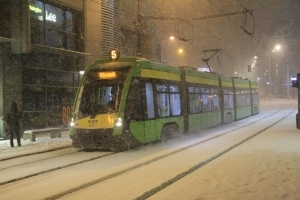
[0,99,300,199]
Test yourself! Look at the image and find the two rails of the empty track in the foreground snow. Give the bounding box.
[47,105,296,200]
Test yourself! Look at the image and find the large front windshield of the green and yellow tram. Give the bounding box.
[78,81,123,118]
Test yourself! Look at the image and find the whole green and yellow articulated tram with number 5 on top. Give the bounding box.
[70,50,259,150]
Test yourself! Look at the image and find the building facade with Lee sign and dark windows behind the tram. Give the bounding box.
[0,0,124,138]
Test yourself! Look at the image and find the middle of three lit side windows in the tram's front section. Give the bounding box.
[156,84,170,117]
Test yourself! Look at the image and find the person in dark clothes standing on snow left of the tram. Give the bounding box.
[7,101,22,147]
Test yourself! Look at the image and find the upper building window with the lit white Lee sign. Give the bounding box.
[29,0,83,51]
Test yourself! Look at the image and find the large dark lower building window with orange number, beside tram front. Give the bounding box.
[21,52,83,128]
